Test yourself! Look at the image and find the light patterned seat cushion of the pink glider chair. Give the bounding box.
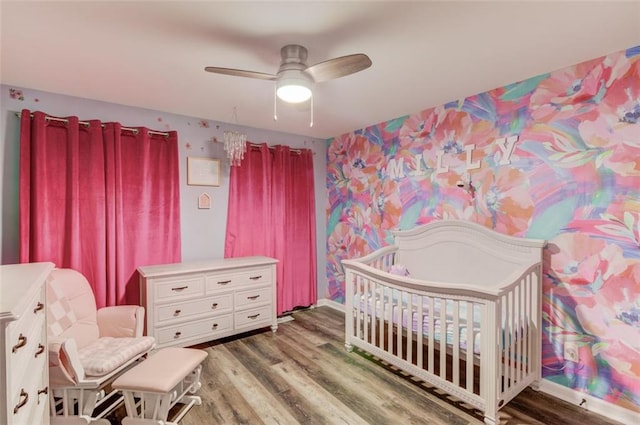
[78,336,155,376]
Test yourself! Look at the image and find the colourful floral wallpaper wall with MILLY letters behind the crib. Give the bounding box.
[327,46,640,412]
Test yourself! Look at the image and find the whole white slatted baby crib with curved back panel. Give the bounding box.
[342,220,546,425]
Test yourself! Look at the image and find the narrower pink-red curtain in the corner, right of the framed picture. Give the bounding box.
[225,144,317,315]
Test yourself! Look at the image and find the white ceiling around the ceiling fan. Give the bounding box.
[0,0,640,138]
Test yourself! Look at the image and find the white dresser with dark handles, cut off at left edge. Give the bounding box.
[0,263,54,425]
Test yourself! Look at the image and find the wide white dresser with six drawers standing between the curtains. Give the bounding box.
[138,257,278,348]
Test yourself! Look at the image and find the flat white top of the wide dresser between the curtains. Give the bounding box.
[138,256,278,277]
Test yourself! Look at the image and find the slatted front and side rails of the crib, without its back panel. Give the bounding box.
[343,247,541,424]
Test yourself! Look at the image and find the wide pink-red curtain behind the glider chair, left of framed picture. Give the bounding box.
[19,110,181,307]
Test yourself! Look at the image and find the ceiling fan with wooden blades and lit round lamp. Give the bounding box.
[205,44,371,103]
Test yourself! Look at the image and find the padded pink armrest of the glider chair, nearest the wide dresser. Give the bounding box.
[97,305,144,338]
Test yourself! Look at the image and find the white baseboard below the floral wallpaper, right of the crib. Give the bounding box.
[539,379,640,424]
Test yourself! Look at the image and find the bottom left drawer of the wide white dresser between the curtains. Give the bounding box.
[154,314,233,345]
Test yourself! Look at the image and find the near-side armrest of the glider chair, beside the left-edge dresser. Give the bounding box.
[47,338,85,388]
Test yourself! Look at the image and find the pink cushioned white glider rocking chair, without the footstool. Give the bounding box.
[46,269,155,425]
